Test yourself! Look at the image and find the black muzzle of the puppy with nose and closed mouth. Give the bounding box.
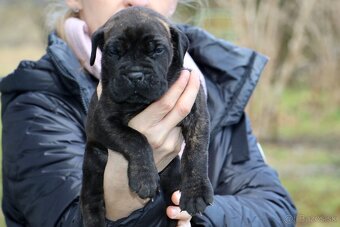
[110,70,168,104]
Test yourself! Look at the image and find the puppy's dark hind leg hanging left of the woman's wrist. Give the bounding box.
[80,144,107,227]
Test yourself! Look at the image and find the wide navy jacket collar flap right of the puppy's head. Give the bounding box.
[179,25,268,131]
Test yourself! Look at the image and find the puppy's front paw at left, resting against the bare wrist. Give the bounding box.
[129,163,159,199]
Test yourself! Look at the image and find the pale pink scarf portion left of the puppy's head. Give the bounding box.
[65,17,102,80]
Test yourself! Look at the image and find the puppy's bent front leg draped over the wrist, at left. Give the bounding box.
[93,118,159,199]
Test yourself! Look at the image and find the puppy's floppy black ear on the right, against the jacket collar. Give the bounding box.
[170,26,189,69]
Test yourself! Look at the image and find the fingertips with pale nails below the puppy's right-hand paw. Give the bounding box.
[166,191,191,227]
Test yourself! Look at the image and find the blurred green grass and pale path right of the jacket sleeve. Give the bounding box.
[263,87,340,227]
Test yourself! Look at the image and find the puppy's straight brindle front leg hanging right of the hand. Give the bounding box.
[180,88,213,214]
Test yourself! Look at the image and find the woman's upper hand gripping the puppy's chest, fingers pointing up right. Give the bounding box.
[129,70,200,172]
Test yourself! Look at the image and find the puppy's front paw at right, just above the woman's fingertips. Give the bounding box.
[179,178,214,215]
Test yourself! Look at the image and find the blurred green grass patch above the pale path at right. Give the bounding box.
[279,86,340,139]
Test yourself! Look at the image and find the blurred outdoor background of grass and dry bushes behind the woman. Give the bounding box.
[0,0,340,227]
